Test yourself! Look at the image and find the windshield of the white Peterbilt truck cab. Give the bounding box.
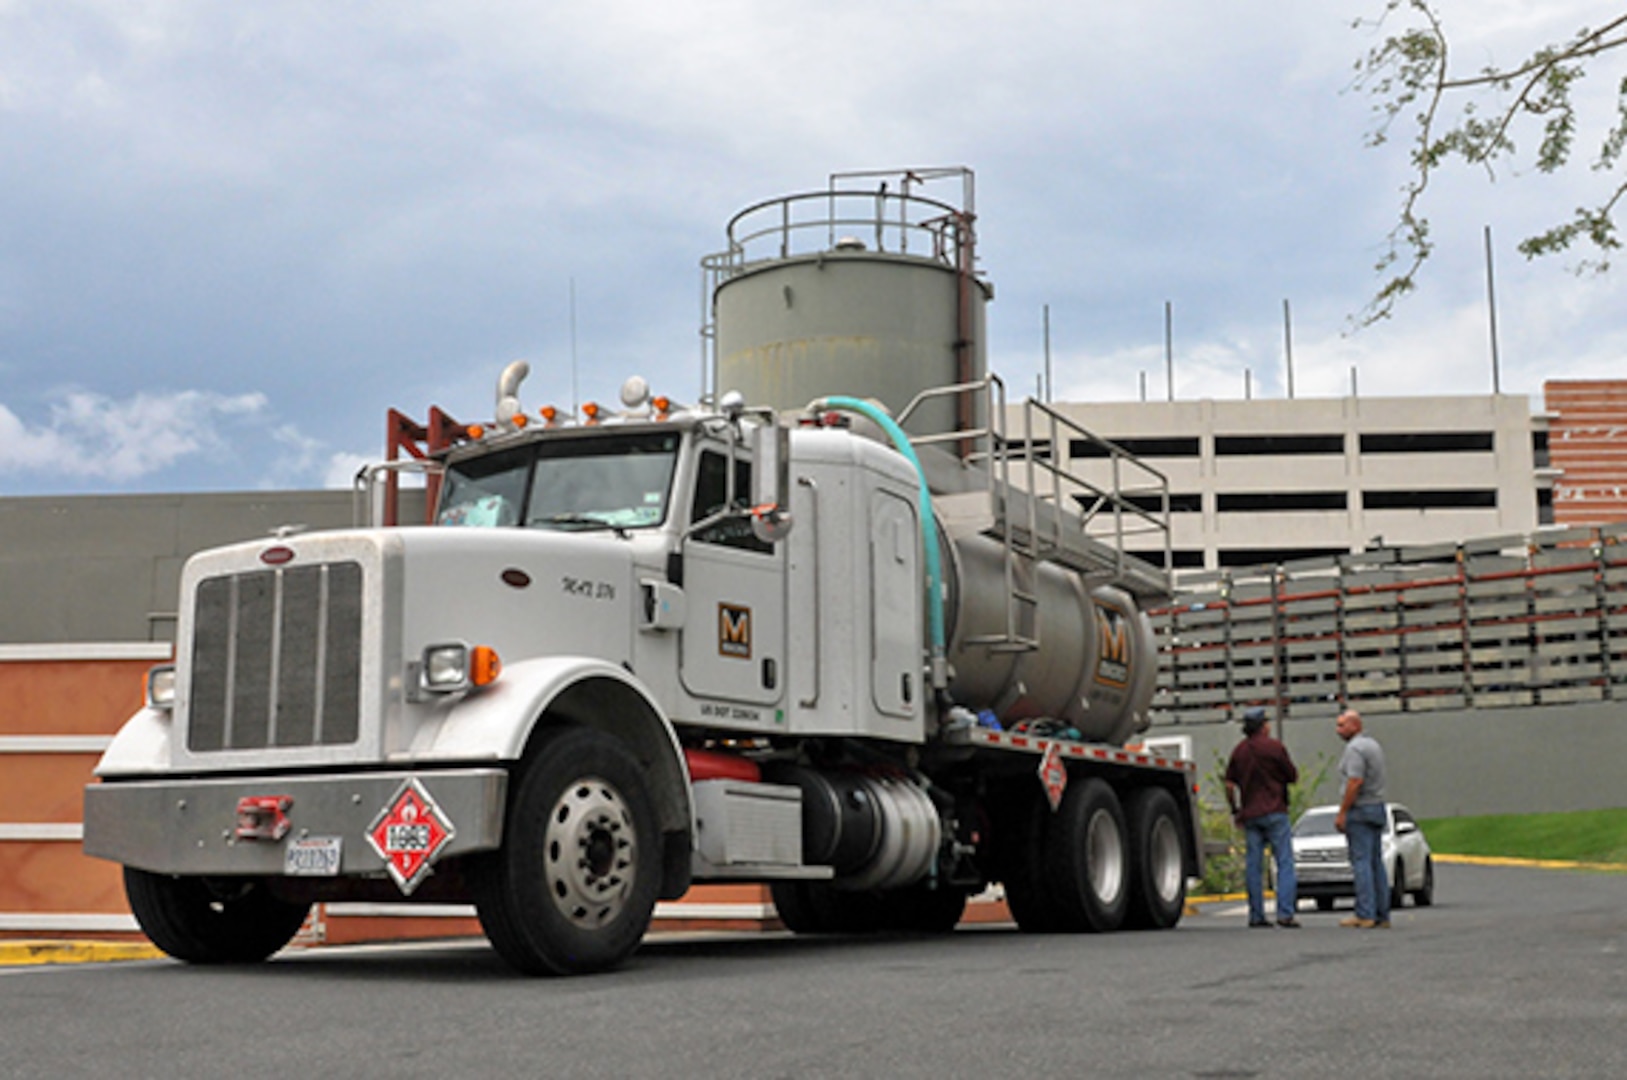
[436,431,680,530]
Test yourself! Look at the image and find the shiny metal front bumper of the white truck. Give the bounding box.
[85,769,508,877]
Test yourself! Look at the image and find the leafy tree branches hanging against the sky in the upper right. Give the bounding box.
[1355,0,1627,325]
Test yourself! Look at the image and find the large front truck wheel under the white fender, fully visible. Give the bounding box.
[470,727,661,974]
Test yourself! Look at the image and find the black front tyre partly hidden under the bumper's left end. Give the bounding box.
[124,867,311,965]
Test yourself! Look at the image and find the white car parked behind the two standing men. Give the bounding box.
[1293,802,1435,911]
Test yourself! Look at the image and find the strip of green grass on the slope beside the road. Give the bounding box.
[1422,808,1627,865]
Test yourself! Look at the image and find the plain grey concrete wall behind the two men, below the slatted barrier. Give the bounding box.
[1147,701,1627,818]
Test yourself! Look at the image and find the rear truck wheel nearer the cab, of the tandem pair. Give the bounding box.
[1046,777,1129,934]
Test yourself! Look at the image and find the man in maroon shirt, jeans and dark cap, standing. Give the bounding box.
[1225,706,1300,929]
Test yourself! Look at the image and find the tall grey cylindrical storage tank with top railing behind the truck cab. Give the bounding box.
[703,171,992,434]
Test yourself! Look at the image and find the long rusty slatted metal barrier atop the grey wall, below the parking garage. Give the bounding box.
[1150,524,1627,724]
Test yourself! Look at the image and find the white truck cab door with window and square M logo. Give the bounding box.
[680,449,786,715]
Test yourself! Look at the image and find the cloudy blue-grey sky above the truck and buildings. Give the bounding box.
[0,0,1627,494]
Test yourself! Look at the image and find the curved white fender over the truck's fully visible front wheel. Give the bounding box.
[413,655,695,858]
